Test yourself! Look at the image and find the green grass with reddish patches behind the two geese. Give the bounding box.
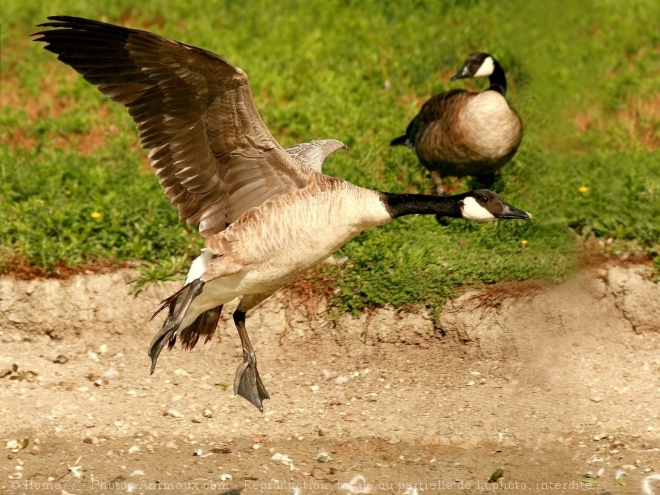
[0,0,660,311]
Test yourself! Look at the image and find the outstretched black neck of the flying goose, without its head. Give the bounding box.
[380,193,466,218]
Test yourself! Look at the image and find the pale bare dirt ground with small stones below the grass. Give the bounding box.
[0,266,660,495]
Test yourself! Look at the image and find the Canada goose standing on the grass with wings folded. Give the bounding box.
[390,53,522,195]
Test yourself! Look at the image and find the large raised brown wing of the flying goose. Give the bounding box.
[34,16,310,237]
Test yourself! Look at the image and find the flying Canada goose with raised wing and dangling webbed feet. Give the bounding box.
[35,16,531,411]
